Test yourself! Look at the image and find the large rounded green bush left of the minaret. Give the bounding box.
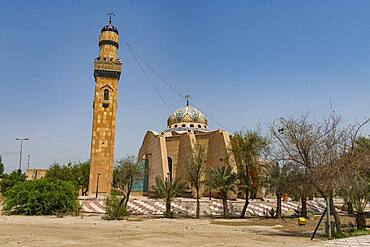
[4,178,79,215]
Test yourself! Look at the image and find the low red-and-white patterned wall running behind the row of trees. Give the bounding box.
[79,196,332,216]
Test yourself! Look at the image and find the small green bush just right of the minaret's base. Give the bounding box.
[103,193,128,220]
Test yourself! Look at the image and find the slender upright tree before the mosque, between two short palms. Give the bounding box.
[185,144,206,218]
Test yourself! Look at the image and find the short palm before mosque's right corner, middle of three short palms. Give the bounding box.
[207,166,237,218]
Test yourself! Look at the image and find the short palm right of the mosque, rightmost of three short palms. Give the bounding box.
[265,162,289,219]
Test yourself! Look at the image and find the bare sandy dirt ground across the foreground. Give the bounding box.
[0,215,352,246]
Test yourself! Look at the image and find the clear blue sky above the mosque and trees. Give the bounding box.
[0,0,370,171]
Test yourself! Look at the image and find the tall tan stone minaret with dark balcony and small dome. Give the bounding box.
[89,15,122,195]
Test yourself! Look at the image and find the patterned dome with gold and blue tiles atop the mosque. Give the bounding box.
[167,104,208,130]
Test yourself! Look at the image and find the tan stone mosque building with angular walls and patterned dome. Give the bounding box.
[138,100,236,194]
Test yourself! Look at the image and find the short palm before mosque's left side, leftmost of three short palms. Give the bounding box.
[151,177,186,218]
